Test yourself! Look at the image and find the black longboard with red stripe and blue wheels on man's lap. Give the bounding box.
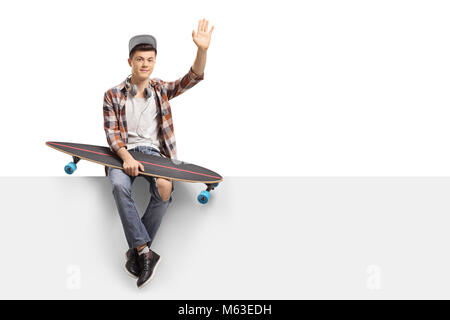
[45,141,223,204]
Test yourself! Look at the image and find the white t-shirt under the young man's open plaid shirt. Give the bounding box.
[125,88,160,150]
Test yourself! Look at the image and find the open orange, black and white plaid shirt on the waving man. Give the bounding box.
[103,67,204,159]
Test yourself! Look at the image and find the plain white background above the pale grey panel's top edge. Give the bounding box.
[0,0,450,176]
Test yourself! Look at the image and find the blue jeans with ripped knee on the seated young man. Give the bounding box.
[108,146,174,248]
